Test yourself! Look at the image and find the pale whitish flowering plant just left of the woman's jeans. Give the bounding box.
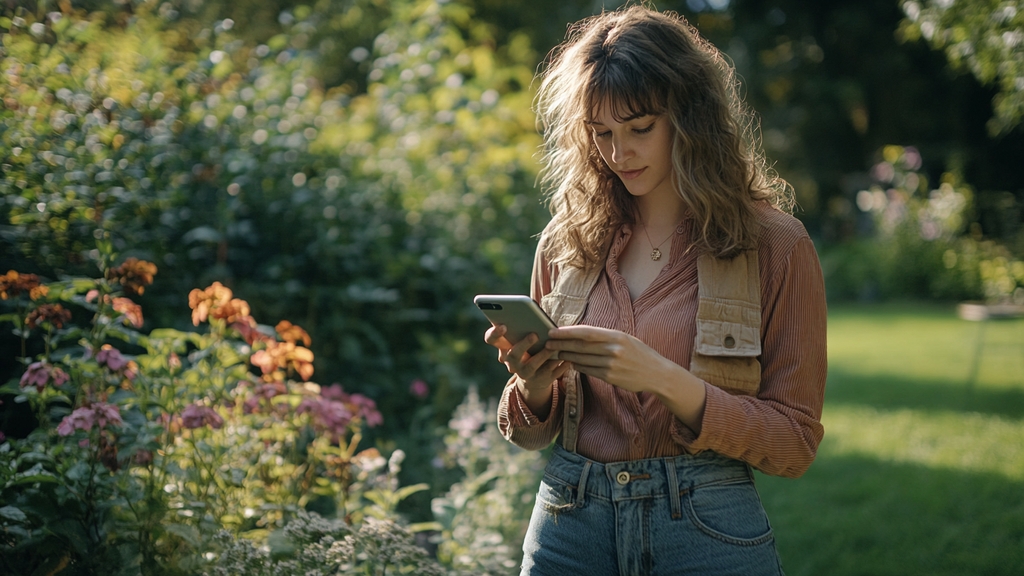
[431,388,547,575]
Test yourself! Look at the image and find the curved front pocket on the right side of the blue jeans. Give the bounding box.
[683,479,772,546]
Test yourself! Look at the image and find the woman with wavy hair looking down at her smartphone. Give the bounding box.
[485,6,825,575]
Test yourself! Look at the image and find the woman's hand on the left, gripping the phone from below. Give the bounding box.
[483,324,571,412]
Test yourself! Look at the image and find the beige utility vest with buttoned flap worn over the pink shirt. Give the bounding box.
[541,249,761,452]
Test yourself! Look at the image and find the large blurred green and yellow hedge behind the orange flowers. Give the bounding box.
[0,0,546,494]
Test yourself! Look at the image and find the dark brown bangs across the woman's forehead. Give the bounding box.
[582,58,668,122]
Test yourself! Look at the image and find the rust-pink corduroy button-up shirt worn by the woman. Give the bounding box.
[498,203,826,478]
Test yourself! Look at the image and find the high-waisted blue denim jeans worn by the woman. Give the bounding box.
[521,445,782,576]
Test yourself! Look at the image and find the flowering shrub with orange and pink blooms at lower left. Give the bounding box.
[0,260,444,574]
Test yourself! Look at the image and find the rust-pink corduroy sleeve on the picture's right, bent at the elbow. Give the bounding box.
[672,237,827,478]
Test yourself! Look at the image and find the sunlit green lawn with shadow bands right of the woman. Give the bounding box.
[758,304,1024,576]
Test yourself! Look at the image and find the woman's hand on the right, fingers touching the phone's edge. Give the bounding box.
[546,326,682,393]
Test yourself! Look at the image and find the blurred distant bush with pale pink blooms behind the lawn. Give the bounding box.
[822,146,1024,302]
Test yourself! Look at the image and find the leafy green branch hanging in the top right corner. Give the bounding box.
[898,0,1024,135]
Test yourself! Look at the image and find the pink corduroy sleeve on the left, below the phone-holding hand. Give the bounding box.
[498,229,562,450]
